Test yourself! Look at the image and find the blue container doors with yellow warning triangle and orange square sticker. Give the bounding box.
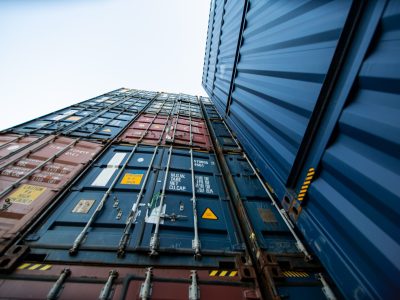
[26,145,244,266]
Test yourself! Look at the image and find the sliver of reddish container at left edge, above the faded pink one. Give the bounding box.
[0,133,44,164]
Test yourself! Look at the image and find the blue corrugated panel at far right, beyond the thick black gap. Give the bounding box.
[298,1,400,299]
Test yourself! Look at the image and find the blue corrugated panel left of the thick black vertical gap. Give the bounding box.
[225,1,351,183]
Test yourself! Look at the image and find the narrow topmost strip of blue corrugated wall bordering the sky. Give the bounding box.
[212,0,245,107]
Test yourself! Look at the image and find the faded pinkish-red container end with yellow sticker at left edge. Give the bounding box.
[0,136,103,253]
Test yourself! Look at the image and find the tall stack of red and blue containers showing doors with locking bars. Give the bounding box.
[0,89,340,299]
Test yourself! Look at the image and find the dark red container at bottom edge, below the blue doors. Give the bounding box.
[0,262,261,300]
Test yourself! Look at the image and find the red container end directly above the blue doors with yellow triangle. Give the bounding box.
[119,113,213,151]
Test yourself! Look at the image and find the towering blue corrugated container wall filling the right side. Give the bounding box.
[205,1,400,299]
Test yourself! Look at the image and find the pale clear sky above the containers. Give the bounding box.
[0,0,210,129]
